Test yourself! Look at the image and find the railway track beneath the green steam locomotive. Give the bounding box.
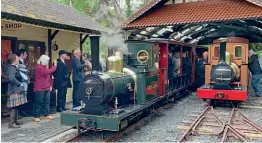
[67,102,174,142]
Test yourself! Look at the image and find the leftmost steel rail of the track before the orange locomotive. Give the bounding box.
[179,106,211,142]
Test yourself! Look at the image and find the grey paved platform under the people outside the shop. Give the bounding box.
[1,103,76,142]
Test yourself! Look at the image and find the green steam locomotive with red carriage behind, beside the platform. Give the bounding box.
[61,40,205,131]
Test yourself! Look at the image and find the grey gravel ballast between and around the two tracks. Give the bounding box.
[119,93,262,142]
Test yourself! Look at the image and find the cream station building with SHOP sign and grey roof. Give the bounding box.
[1,0,108,114]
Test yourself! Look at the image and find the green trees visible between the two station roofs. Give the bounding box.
[52,0,151,53]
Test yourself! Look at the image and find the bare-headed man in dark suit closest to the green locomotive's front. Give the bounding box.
[72,49,86,108]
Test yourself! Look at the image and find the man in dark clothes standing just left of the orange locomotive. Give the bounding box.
[196,51,208,88]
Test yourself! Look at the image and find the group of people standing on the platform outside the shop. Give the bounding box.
[3,49,106,128]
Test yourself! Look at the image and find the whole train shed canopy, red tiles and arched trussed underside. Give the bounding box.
[123,0,262,44]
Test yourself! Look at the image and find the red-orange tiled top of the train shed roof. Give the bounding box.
[123,0,262,29]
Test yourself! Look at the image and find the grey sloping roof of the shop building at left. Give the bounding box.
[1,0,109,34]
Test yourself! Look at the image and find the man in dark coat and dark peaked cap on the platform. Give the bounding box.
[54,50,70,112]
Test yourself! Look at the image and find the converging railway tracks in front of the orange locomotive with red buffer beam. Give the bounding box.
[178,106,262,142]
